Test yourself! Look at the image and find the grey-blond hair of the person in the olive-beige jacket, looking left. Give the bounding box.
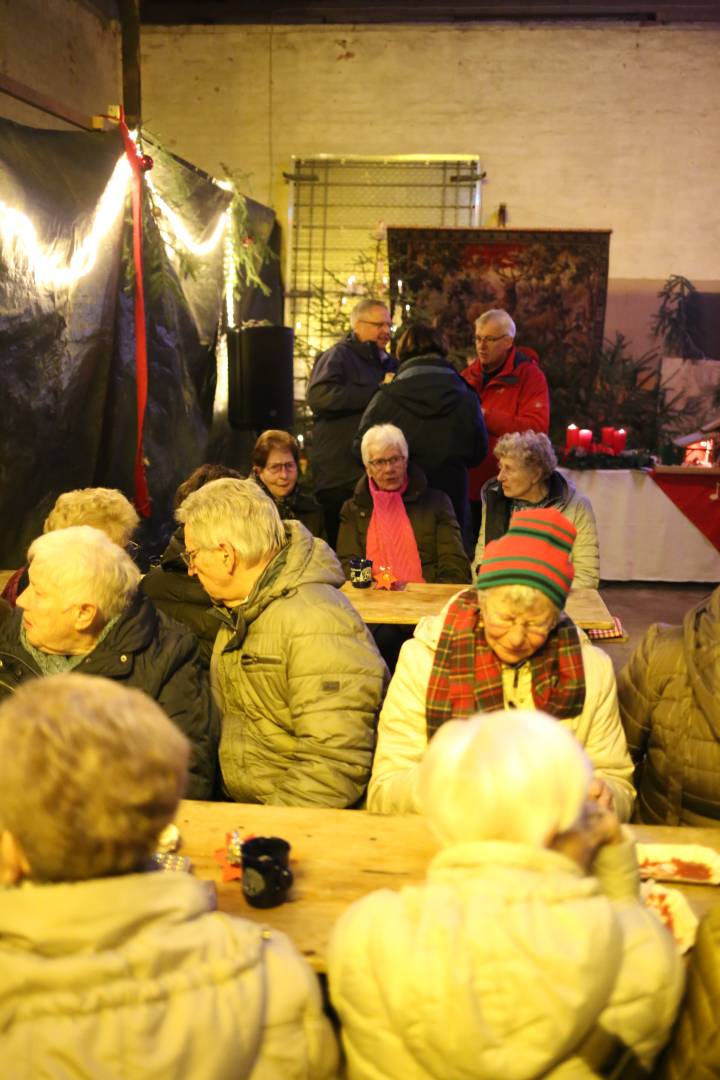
[175,478,287,567]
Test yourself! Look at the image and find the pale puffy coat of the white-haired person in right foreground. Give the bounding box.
[328,841,682,1080]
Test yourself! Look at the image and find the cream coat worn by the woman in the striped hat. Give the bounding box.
[367,602,635,821]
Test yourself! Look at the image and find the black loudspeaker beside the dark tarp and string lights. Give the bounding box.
[228,326,294,432]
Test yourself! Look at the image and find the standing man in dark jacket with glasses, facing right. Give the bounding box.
[308,298,396,548]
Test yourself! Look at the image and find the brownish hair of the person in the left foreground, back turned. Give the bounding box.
[0,674,189,881]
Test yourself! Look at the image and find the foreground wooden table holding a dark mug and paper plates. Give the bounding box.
[176,801,720,971]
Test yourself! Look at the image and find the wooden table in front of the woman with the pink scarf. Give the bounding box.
[342,581,614,630]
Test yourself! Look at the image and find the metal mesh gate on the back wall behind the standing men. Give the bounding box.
[286,156,481,399]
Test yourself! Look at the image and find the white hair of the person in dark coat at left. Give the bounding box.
[27,525,141,624]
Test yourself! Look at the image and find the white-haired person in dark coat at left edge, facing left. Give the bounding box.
[0,525,219,799]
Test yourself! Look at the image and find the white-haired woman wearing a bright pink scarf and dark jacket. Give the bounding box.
[337,423,471,584]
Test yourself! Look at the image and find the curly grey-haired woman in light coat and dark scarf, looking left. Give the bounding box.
[474,431,600,589]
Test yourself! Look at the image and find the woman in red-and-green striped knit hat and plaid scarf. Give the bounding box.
[368,509,635,821]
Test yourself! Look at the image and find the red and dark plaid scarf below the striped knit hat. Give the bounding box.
[425,589,585,740]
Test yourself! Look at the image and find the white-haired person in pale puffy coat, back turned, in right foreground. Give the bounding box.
[328,712,683,1080]
